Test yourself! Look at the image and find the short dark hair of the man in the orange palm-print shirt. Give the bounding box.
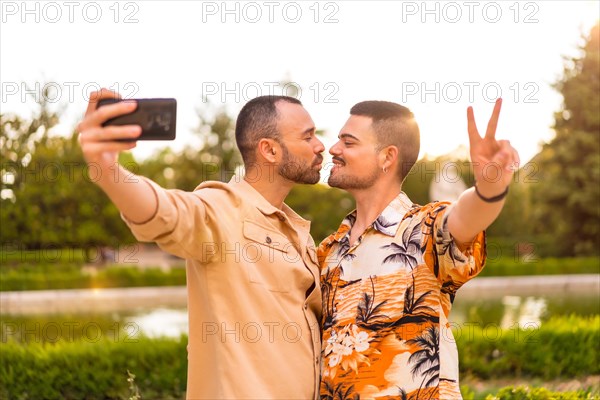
[350,100,421,181]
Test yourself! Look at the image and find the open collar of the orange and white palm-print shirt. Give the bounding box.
[333,192,413,242]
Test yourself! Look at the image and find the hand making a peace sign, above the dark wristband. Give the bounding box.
[467,99,520,197]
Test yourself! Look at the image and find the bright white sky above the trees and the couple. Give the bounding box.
[0,0,600,162]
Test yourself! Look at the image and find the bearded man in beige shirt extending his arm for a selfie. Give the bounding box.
[78,90,324,399]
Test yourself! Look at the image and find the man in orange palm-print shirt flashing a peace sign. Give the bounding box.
[318,99,519,399]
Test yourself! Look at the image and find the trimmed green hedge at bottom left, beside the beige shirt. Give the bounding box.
[0,338,187,399]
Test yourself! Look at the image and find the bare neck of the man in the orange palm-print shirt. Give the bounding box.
[350,179,402,229]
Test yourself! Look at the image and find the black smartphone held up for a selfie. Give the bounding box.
[96,99,177,141]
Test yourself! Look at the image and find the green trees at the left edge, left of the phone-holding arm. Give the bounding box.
[0,87,133,249]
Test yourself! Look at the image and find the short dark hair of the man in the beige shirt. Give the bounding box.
[235,96,302,165]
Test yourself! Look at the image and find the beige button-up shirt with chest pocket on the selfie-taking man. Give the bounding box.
[125,176,321,399]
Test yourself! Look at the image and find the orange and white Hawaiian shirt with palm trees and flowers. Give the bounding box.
[318,192,486,399]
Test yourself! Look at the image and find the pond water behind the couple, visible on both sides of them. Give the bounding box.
[0,292,600,343]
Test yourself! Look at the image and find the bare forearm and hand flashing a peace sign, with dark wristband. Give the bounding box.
[448,99,519,244]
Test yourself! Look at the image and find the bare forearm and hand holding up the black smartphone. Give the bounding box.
[78,89,158,223]
